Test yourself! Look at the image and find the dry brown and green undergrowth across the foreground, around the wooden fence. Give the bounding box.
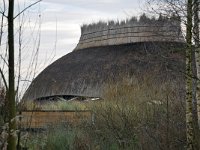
[18,76,186,150]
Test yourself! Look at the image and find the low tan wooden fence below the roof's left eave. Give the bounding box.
[20,110,93,129]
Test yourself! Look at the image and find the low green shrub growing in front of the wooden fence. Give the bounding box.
[22,123,90,150]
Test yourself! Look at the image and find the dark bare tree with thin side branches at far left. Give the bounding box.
[0,0,41,150]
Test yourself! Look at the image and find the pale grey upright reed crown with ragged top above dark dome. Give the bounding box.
[75,14,185,50]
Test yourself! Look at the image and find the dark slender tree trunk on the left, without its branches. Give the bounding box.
[8,0,16,150]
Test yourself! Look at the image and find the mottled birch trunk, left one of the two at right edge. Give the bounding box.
[186,0,194,150]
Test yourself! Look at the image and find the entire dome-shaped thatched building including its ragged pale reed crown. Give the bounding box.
[23,16,184,100]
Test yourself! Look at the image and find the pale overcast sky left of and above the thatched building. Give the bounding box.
[0,0,145,95]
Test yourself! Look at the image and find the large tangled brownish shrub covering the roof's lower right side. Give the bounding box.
[86,78,186,150]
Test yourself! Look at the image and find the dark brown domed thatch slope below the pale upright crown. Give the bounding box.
[23,42,184,100]
